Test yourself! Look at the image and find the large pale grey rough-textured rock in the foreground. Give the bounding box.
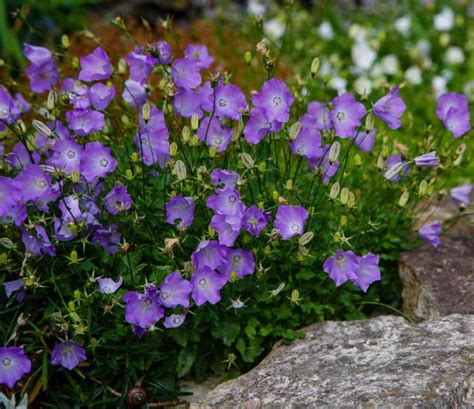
[191,315,474,409]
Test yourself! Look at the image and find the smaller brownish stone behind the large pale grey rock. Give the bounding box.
[399,193,474,320]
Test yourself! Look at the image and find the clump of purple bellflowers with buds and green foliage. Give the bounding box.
[0,9,472,396]
